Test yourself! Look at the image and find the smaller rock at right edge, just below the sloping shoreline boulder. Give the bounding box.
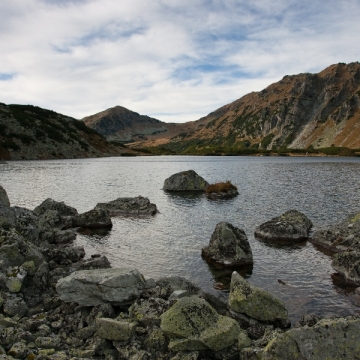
[331,249,360,285]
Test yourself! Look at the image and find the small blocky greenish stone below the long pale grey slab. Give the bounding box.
[96,318,136,341]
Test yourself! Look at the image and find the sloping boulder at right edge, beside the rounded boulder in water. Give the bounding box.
[309,213,360,252]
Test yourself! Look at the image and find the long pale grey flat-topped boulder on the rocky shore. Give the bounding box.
[56,268,145,306]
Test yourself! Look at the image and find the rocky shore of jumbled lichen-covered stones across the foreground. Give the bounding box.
[0,186,360,360]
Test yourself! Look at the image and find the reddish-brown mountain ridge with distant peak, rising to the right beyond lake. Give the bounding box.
[84,62,360,153]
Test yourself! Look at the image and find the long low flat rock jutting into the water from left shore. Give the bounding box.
[95,196,157,216]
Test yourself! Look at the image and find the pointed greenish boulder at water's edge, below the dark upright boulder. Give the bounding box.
[229,271,288,322]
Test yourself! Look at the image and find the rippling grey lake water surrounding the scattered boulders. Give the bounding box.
[0,156,360,320]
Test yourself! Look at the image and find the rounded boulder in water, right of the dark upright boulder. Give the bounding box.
[255,210,312,243]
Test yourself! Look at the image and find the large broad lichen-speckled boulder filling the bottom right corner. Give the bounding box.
[261,317,360,360]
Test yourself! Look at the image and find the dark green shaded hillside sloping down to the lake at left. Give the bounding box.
[0,103,136,160]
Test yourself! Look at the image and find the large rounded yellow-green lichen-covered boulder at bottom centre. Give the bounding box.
[160,296,240,351]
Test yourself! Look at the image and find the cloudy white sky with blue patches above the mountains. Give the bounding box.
[0,0,360,122]
